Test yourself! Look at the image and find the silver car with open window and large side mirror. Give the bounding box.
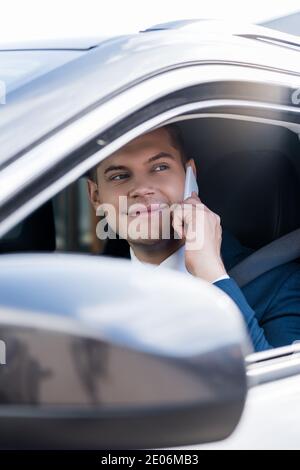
[0,20,300,450]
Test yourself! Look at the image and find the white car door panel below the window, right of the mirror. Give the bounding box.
[179,344,300,450]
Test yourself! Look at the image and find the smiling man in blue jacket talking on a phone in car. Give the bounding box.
[88,125,300,351]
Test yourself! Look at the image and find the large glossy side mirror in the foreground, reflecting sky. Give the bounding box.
[0,254,251,449]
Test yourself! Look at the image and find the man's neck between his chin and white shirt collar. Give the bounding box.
[129,239,184,264]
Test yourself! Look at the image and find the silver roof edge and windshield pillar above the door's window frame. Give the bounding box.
[0,20,300,167]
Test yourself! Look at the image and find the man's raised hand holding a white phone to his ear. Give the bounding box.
[172,191,227,282]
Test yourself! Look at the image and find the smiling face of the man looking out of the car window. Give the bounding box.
[89,128,194,244]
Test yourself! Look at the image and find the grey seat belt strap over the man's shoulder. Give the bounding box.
[228,228,300,287]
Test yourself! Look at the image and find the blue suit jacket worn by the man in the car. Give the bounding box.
[215,230,300,351]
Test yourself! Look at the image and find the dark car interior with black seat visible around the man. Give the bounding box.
[0,113,300,280]
